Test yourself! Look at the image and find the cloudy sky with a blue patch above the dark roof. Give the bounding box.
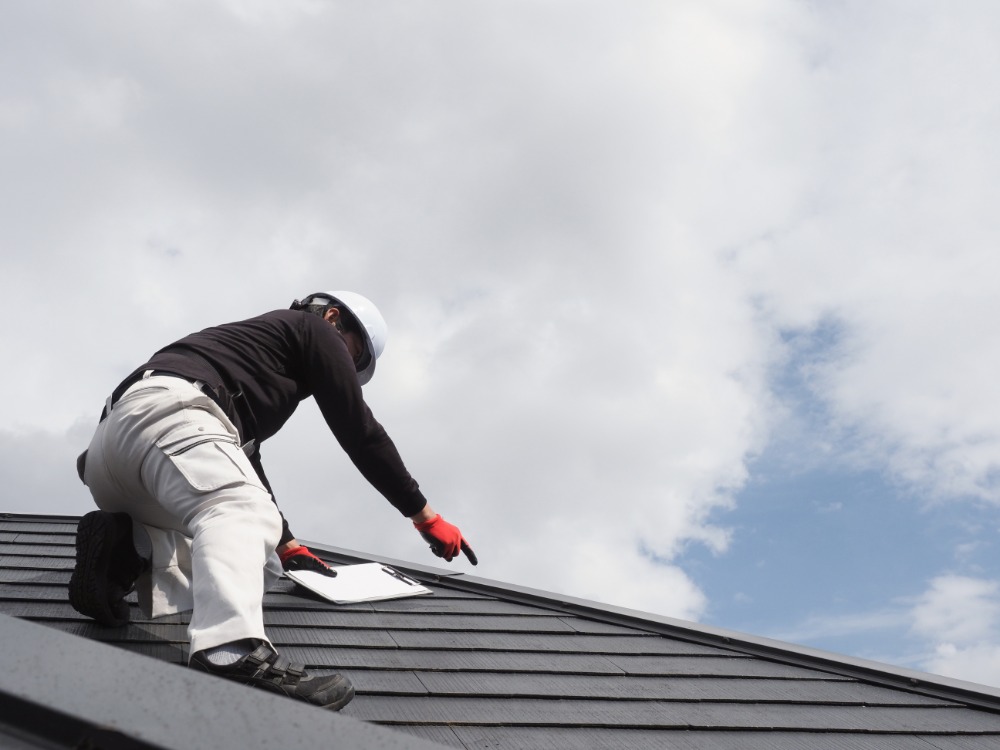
[0,0,1000,686]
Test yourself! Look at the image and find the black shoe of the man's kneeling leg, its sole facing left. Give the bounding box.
[69,510,149,627]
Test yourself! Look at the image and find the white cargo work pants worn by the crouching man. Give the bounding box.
[84,375,281,654]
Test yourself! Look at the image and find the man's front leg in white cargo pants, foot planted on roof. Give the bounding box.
[142,394,354,710]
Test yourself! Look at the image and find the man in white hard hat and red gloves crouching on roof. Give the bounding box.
[69,292,477,710]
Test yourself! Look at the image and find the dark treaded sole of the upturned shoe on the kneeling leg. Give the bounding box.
[69,510,131,627]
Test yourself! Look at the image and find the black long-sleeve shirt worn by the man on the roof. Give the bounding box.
[120,310,427,543]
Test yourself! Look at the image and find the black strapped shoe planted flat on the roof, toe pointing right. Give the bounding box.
[190,643,354,711]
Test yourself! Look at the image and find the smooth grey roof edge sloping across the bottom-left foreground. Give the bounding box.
[0,614,450,750]
